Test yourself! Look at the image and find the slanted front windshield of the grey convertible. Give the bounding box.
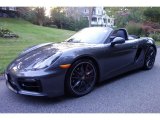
[66,27,112,44]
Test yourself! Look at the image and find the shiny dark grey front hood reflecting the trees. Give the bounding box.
[9,42,96,70]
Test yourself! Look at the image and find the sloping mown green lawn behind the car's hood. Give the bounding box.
[0,18,74,73]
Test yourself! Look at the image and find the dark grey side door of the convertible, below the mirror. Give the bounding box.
[103,30,137,78]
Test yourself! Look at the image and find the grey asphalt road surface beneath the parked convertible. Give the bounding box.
[0,49,160,113]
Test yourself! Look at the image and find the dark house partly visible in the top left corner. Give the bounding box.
[0,7,17,18]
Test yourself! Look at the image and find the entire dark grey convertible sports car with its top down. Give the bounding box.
[5,27,157,97]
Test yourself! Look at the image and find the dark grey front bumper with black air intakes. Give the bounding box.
[5,69,66,97]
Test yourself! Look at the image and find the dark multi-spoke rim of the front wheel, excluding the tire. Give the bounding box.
[70,62,96,94]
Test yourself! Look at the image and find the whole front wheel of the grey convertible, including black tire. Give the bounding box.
[66,59,97,97]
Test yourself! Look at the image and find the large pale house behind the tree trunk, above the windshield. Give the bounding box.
[65,7,114,27]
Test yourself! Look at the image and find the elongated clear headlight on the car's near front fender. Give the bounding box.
[33,52,62,70]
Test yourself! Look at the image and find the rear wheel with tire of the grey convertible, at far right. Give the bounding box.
[144,46,156,70]
